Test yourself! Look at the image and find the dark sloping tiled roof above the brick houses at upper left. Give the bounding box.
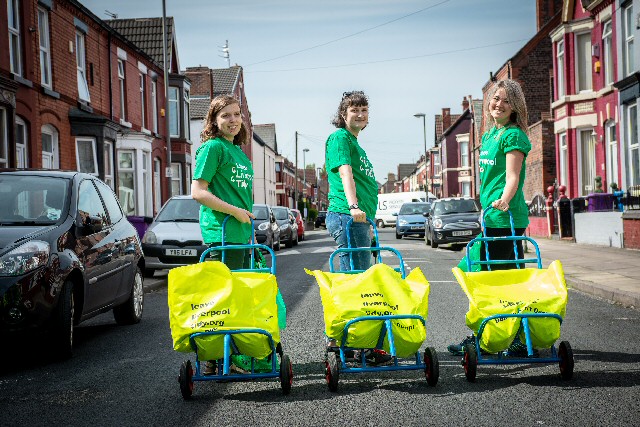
[104,16,175,67]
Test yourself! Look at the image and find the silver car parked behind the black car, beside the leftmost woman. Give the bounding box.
[142,196,207,277]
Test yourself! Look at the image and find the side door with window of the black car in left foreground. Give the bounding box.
[76,179,122,313]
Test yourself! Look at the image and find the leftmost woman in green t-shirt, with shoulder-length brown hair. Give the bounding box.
[191,95,255,270]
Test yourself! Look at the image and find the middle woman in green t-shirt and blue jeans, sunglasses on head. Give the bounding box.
[325,91,392,365]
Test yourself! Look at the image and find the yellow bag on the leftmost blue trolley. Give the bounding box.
[168,261,280,360]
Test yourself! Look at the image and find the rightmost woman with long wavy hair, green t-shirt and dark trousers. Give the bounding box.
[448,80,531,354]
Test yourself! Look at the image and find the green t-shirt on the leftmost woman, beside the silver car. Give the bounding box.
[193,138,253,244]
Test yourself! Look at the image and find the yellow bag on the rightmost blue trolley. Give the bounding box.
[453,260,568,353]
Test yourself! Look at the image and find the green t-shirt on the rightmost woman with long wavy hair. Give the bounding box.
[479,126,531,228]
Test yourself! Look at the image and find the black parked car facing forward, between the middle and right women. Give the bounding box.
[424,197,481,248]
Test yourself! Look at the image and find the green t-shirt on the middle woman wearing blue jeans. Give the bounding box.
[326,128,378,219]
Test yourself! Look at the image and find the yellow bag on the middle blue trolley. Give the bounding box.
[305,264,429,357]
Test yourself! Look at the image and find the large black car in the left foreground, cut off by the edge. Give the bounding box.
[0,169,144,358]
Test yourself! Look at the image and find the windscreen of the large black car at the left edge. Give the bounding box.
[0,174,70,225]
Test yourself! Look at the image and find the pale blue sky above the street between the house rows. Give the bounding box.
[80,0,536,183]
